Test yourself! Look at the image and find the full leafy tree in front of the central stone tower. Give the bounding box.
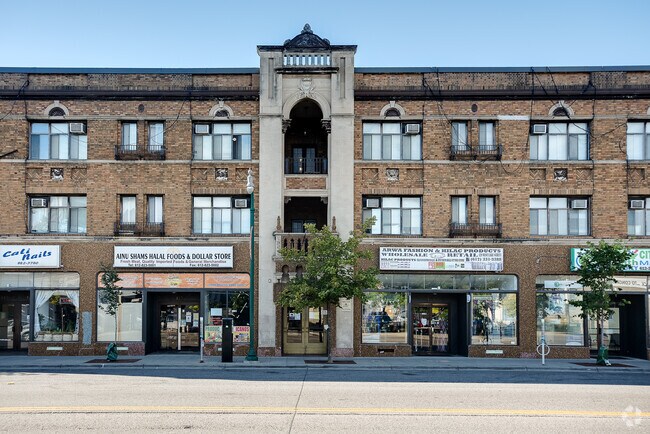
[278,219,379,363]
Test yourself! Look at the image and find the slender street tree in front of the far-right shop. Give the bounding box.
[569,240,632,364]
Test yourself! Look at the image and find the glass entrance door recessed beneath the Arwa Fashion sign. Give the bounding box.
[412,303,449,354]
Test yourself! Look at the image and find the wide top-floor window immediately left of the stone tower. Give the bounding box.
[194,123,251,160]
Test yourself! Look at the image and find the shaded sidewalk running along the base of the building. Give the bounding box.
[0,353,650,373]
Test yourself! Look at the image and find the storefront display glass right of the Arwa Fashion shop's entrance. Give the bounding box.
[472,293,517,345]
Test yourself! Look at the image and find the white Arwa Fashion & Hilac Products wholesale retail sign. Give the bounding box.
[379,247,503,271]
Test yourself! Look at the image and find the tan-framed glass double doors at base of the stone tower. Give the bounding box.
[283,307,327,355]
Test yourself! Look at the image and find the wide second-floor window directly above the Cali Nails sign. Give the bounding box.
[29,196,86,234]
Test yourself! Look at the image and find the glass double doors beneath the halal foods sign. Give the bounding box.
[160,304,199,351]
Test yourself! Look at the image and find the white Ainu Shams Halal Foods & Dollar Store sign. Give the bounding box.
[113,246,233,268]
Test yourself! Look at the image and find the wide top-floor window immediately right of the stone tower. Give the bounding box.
[363,122,422,160]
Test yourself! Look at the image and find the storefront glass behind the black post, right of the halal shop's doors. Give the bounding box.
[204,291,250,343]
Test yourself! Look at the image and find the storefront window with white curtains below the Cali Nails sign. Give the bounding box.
[34,289,79,342]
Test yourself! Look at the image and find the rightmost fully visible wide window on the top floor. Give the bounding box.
[530,123,589,160]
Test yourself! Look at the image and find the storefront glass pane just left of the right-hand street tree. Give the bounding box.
[537,292,585,346]
